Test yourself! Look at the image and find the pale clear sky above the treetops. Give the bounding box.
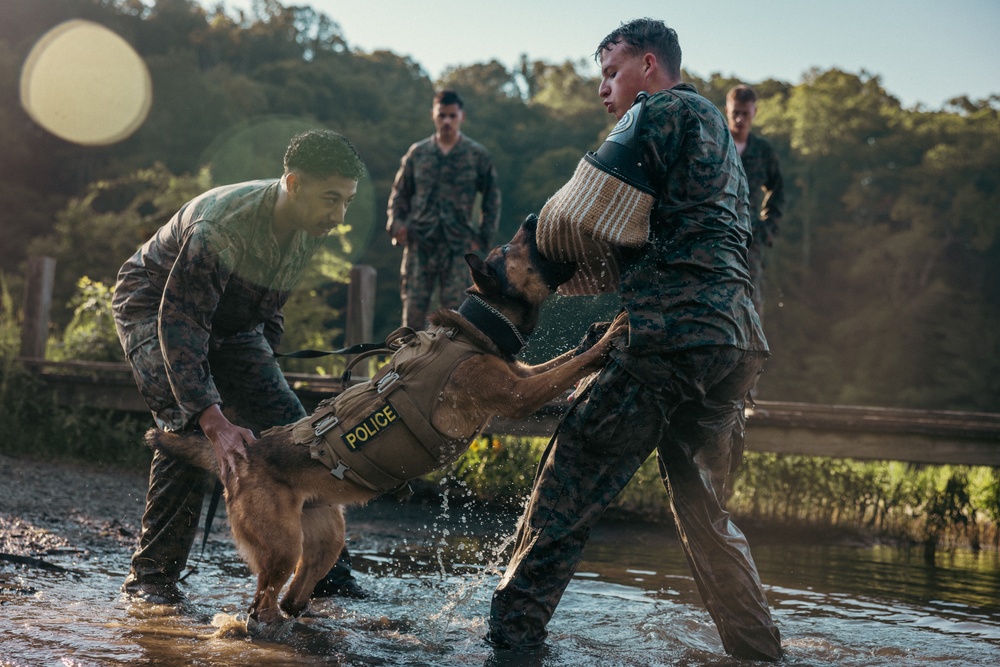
[213,0,1000,109]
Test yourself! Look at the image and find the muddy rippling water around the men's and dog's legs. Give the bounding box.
[0,500,1000,667]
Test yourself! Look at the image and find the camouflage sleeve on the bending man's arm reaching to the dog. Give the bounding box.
[158,224,236,425]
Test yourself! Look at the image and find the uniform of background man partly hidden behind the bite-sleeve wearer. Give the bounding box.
[740,132,785,322]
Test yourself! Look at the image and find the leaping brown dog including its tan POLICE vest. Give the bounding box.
[146,216,628,623]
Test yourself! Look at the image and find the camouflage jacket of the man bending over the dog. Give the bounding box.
[112,180,323,428]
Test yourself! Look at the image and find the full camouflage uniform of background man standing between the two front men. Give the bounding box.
[387,135,500,329]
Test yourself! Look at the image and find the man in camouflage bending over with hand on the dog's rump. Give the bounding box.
[112,130,366,604]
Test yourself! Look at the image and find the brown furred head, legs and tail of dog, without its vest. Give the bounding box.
[146,216,628,623]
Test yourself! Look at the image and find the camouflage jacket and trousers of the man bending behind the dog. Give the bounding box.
[112,180,348,586]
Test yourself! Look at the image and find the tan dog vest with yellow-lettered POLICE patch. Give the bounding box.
[271,326,485,493]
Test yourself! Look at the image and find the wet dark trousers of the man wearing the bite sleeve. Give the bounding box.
[489,347,781,660]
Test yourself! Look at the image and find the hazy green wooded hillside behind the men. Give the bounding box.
[0,0,1000,412]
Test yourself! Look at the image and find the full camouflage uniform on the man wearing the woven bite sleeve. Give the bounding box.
[489,84,781,659]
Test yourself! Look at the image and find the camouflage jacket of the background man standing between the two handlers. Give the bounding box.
[386,134,500,252]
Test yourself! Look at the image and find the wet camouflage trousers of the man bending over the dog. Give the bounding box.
[125,336,351,588]
